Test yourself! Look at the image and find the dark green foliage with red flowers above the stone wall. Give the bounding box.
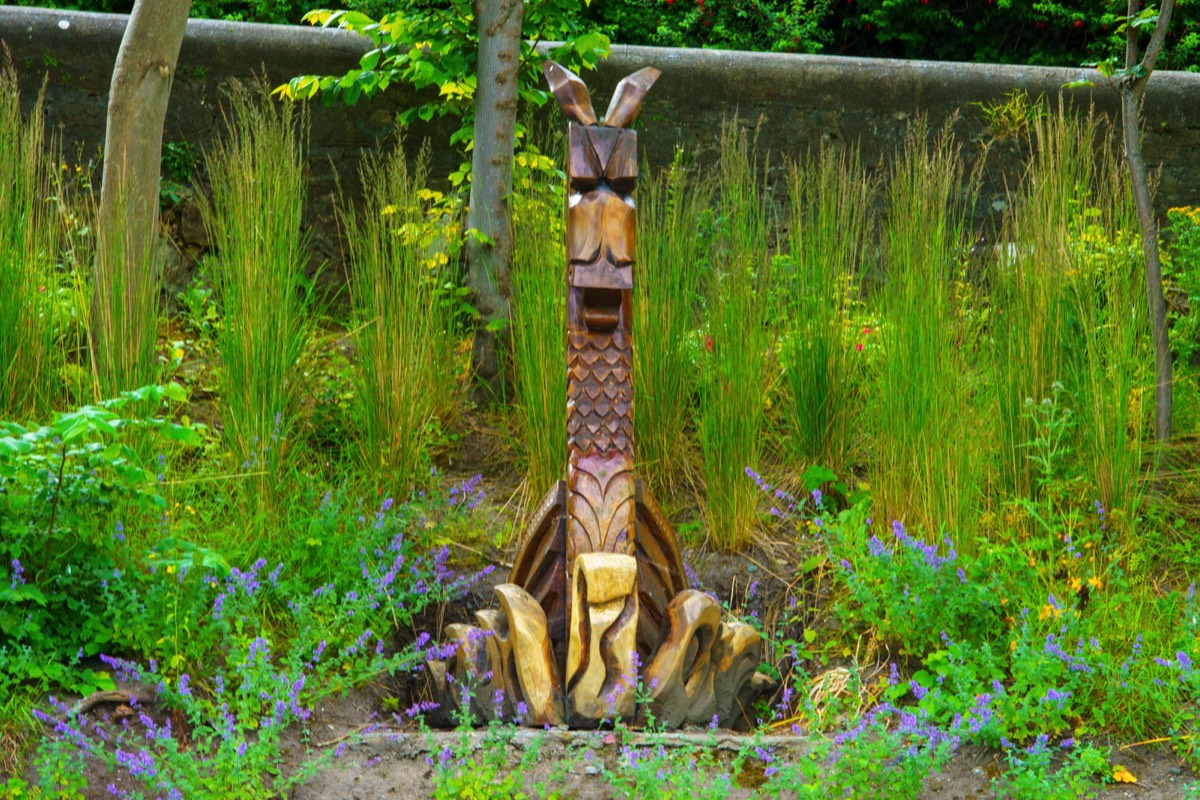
[17,0,1200,71]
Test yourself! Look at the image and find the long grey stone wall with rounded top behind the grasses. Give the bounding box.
[0,7,1200,287]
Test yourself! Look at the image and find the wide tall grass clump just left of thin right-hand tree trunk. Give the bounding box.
[989,108,1152,537]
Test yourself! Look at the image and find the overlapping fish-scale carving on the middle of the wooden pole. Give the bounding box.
[566,331,634,458]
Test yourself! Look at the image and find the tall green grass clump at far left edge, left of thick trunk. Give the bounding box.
[0,66,61,419]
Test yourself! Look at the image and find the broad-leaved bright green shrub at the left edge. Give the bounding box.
[0,386,199,693]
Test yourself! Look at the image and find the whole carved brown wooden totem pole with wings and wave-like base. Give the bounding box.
[430,61,770,727]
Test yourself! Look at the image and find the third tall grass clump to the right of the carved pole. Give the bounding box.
[776,148,876,473]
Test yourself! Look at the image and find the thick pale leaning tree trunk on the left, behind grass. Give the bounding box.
[91,0,192,393]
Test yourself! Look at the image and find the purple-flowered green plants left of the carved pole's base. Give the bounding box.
[18,474,480,796]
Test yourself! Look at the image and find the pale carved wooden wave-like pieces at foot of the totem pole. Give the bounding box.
[428,578,774,729]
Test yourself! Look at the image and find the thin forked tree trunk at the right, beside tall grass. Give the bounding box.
[1118,0,1175,444]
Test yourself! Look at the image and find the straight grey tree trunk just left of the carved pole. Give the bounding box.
[467,0,524,396]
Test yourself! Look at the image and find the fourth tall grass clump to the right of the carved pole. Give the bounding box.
[870,122,988,546]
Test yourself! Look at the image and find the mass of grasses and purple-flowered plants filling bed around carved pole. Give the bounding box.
[0,59,1200,798]
